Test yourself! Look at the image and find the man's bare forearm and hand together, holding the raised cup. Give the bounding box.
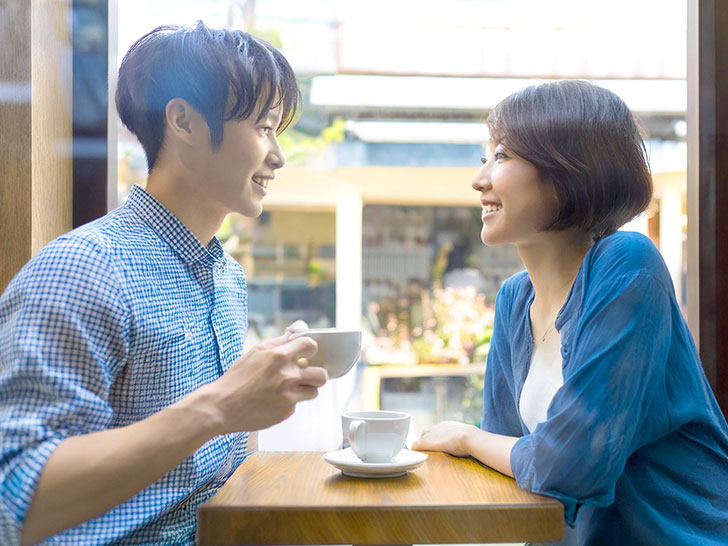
[21,326,328,544]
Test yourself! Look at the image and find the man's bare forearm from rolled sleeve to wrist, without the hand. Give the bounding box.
[21,386,219,544]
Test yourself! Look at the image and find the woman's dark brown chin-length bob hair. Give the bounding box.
[486,80,652,240]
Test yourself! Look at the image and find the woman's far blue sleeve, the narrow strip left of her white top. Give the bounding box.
[480,283,523,436]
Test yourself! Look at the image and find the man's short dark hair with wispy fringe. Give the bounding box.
[116,21,301,171]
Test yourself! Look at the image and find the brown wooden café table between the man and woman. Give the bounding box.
[197,452,564,546]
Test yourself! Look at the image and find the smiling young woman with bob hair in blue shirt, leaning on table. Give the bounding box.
[414,81,728,546]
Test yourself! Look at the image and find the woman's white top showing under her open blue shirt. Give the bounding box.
[518,328,564,432]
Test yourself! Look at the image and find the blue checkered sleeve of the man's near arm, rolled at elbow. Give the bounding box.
[0,239,129,544]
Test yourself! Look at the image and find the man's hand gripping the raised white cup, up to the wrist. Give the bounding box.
[199,332,328,434]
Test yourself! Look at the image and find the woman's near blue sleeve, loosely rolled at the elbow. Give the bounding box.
[511,271,671,525]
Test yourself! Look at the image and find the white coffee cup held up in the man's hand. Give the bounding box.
[291,328,361,379]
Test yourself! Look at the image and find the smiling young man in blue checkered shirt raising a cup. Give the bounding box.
[0,23,327,545]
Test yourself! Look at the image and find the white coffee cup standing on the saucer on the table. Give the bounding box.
[341,411,411,463]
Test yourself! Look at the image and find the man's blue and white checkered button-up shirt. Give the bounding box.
[0,186,248,546]
